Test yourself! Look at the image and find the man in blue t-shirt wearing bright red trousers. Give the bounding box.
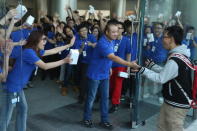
[109,22,131,113]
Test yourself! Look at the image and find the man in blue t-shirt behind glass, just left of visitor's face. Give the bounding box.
[144,23,168,103]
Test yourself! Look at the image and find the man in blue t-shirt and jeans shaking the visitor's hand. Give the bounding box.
[83,20,139,129]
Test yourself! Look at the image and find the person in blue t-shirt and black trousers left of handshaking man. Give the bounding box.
[74,23,96,103]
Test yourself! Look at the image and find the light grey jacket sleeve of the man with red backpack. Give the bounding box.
[139,60,178,84]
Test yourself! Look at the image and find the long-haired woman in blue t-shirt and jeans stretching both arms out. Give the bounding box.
[0,31,75,131]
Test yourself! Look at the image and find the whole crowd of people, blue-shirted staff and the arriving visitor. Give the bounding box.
[0,3,197,131]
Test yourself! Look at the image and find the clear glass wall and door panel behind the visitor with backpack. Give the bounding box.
[131,0,197,127]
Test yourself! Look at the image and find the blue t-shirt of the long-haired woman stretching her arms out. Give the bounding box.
[5,49,44,92]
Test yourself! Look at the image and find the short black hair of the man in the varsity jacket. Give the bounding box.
[164,25,184,45]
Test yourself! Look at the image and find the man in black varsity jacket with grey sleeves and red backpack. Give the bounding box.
[139,26,192,131]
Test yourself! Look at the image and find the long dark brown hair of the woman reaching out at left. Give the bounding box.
[23,31,44,54]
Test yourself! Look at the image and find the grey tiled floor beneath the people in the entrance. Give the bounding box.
[3,75,196,131]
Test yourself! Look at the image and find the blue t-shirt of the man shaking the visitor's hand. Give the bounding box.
[87,35,114,80]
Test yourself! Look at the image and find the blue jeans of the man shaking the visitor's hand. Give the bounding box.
[84,79,109,122]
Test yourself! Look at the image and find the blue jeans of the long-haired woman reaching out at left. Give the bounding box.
[0,89,27,131]
